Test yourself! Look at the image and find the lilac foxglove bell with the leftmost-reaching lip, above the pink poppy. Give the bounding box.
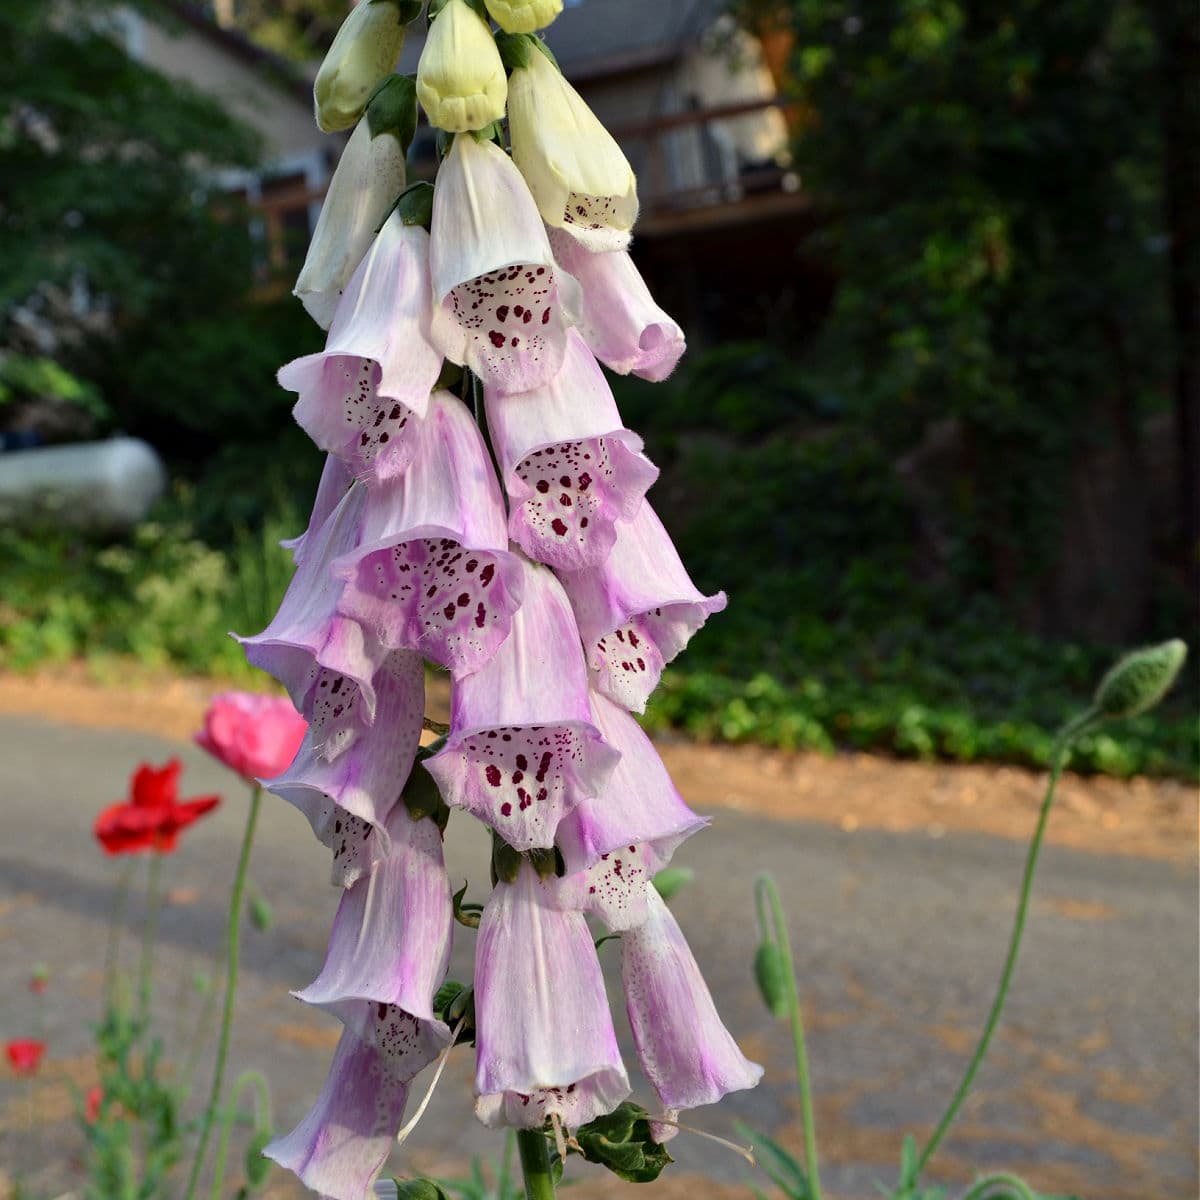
[238,486,379,721]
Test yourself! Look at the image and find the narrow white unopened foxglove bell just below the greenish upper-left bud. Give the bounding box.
[293,120,404,329]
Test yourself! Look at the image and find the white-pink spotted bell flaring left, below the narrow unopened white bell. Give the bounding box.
[280,212,442,480]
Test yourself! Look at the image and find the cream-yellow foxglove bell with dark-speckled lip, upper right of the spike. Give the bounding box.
[509,47,637,251]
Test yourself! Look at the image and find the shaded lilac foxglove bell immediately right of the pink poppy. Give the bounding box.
[265,650,425,887]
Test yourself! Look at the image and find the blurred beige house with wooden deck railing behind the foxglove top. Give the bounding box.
[127,0,828,337]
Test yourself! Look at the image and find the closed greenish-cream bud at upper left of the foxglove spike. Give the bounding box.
[312,0,407,133]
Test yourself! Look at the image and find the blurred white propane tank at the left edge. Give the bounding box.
[0,438,167,533]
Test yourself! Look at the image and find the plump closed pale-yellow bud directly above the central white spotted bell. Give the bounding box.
[416,0,509,133]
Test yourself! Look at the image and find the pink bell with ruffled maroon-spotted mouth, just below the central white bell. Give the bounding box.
[484,329,659,571]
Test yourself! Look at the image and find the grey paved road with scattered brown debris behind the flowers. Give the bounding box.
[0,719,1198,1200]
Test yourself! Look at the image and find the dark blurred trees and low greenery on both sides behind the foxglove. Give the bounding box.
[0,0,1200,774]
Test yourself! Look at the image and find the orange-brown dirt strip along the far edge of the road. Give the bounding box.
[0,666,1200,868]
